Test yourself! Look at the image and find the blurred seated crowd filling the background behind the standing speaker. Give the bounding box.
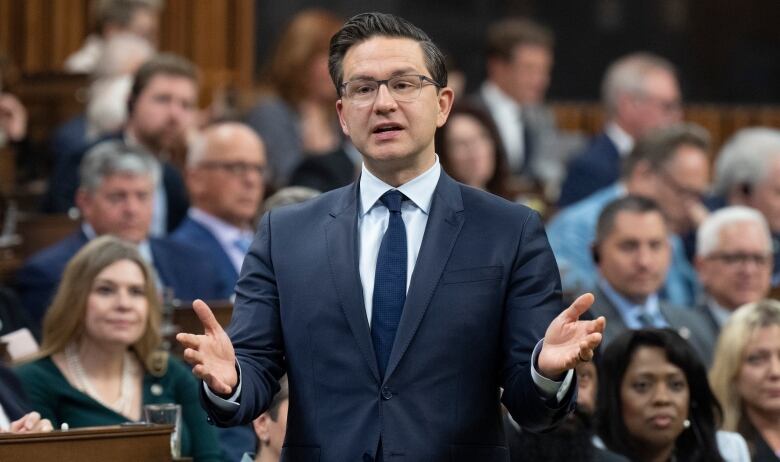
[0,0,780,461]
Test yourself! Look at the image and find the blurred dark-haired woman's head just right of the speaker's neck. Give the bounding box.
[435,103,519,200]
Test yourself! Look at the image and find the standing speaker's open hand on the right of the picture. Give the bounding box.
[538,294,607,379]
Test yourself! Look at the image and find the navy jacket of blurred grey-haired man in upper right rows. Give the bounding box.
[558,133,620,207]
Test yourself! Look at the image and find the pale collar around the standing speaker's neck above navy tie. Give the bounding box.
[360,156,441,217]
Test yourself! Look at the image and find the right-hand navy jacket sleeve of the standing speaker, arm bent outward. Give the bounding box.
[501,212,577,431]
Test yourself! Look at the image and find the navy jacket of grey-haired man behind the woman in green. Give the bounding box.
[16,230,232,324]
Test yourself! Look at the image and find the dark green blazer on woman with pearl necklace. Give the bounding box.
[16,357,222,461]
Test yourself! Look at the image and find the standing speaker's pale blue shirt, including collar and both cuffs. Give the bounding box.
[203,156,574,412]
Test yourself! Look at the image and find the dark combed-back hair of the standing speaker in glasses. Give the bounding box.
[328,13,447,95]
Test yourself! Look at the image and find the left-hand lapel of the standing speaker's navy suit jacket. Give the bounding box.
[325,181,380,382]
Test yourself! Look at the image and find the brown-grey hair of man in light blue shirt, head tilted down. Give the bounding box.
[620,123,710,179]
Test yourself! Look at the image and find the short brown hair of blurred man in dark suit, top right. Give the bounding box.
[485,18,555,60]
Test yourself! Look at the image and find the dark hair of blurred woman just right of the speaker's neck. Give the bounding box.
[434,102,518,200]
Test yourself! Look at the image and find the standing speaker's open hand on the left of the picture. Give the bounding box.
[176,300,238,395]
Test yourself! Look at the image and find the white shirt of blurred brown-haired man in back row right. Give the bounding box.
[481,80,525,172]
